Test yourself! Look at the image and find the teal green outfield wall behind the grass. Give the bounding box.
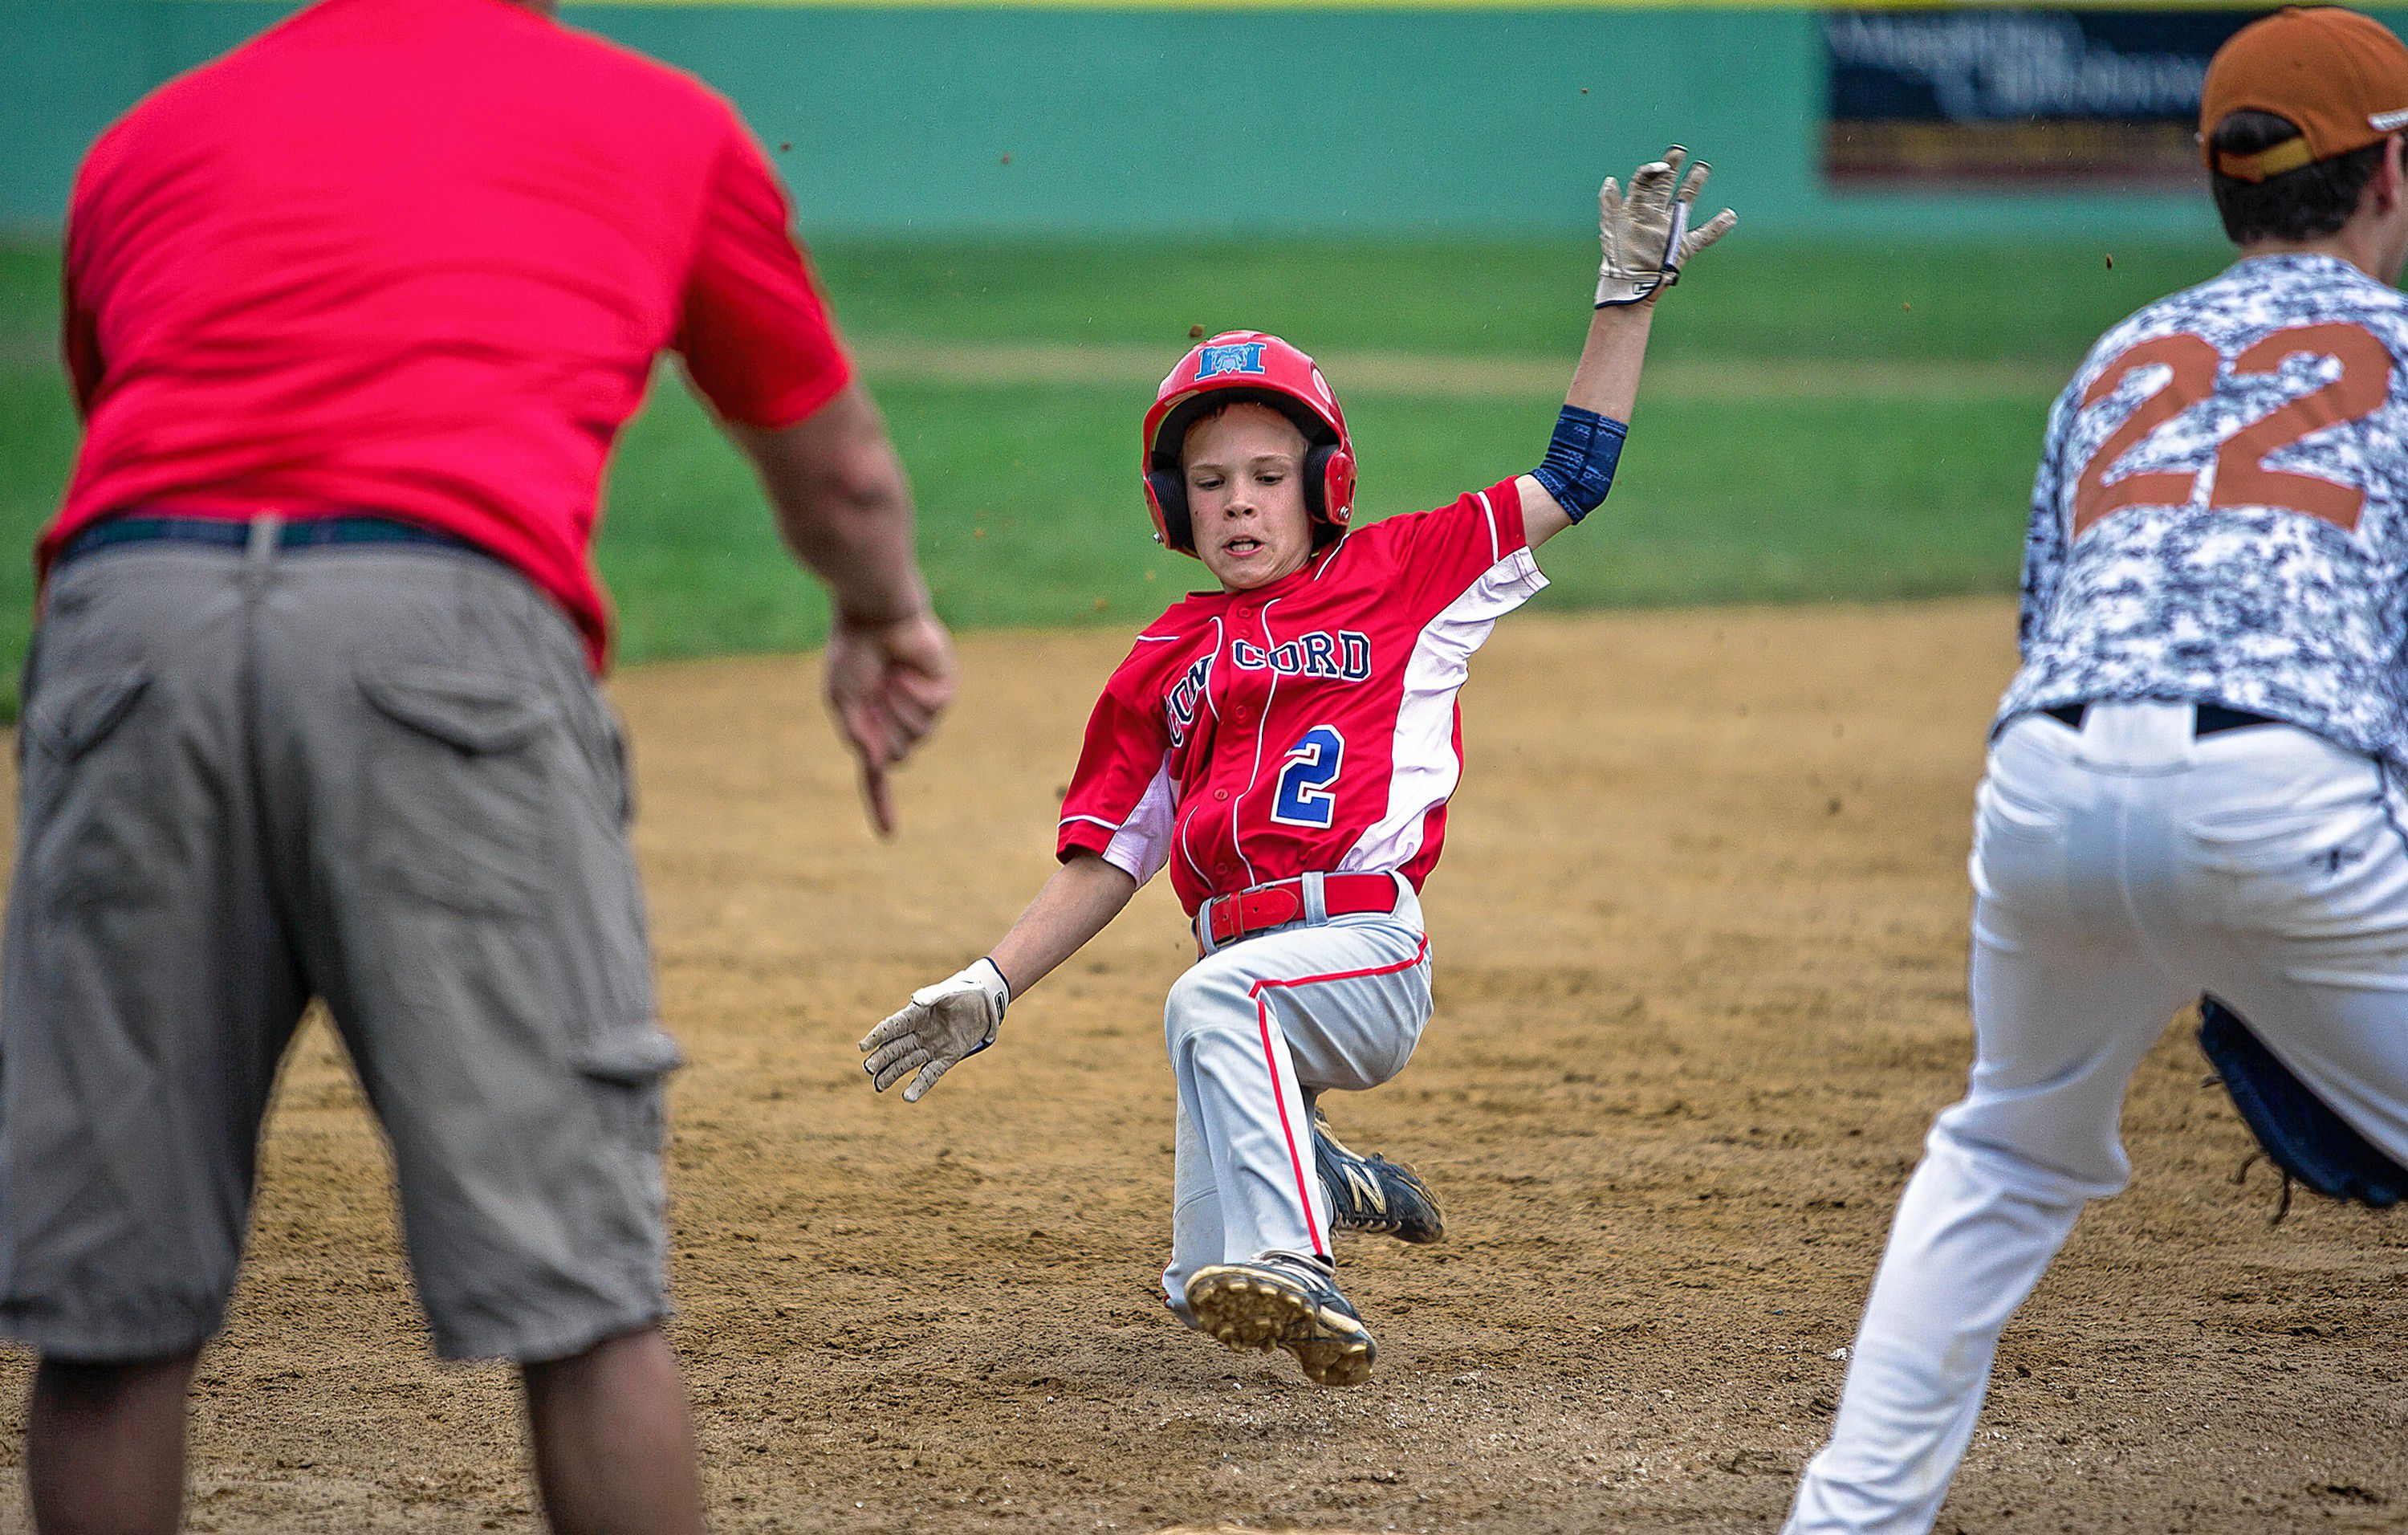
[14,0,2408,241]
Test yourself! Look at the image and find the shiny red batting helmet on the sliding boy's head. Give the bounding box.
[1144,330,1353,554]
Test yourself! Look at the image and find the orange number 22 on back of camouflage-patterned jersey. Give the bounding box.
[2073,323,2391,537]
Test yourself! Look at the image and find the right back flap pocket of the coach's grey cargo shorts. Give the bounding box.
[359,665,559,916]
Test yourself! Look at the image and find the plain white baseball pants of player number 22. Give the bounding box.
[1787,703,2408,1535]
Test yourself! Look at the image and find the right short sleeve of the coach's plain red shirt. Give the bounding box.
[677,123,852,429]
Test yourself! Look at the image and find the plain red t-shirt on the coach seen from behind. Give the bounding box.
[39,0,850,667]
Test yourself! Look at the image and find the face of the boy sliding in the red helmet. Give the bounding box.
[1182,405,1312,592]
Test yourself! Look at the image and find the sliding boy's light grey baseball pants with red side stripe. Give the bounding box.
[1163,877,1430,1316]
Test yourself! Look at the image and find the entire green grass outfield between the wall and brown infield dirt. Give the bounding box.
[0,234,2223,696]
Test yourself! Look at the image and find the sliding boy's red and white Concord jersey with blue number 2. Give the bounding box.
[1057,479,1546,916]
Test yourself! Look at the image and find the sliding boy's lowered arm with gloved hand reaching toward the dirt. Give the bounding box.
[862,853,1137,1104]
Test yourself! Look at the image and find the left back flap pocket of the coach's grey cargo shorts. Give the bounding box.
[19,670,164,906]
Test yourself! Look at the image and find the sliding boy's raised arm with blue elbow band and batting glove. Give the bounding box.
[1515,145,1739,549]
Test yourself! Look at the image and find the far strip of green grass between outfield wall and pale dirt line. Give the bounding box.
[814,231,2227,361]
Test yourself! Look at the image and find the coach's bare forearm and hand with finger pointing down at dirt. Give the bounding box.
[727,383,954,837]
